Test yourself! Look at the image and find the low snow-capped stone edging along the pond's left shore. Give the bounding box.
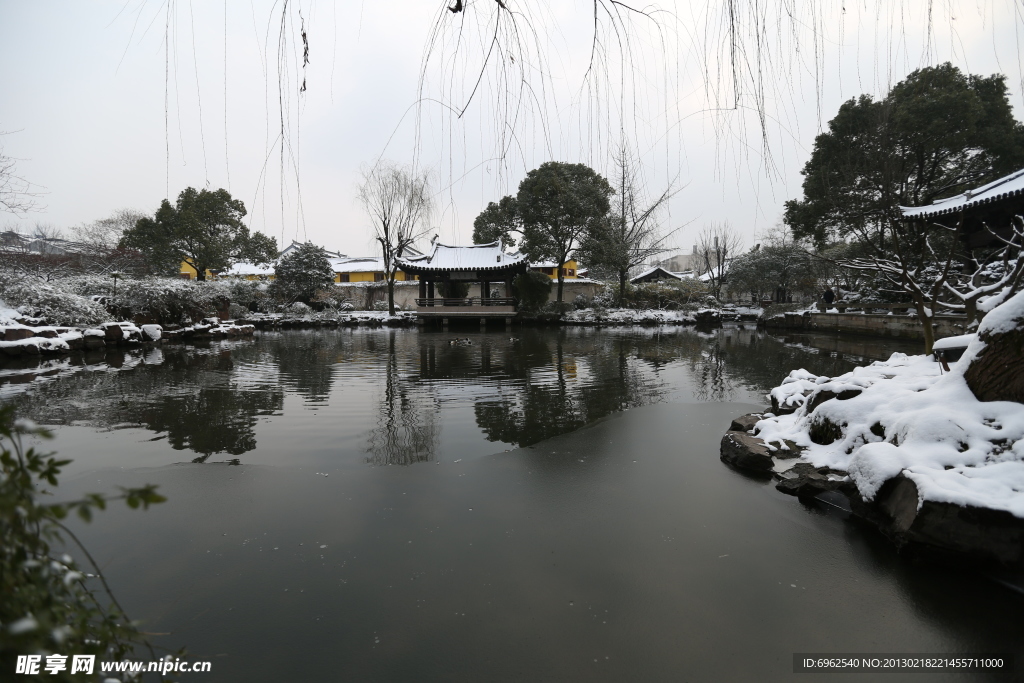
[0,318,256,357]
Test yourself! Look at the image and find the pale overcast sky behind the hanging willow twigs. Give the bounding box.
[0,0,1022,255]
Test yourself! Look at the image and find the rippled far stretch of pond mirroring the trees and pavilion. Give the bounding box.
[0,327,915,465]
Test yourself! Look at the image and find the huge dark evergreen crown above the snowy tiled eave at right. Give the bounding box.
[785,62,1024,245]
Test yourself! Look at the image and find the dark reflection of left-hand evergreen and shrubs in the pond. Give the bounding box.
[7,344,284,462]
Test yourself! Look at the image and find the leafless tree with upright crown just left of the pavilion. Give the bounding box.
[358,161,433,315]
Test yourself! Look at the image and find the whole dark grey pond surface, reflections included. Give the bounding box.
[0,327,1024,681]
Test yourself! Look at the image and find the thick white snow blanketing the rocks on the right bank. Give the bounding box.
[755,293,1024,518]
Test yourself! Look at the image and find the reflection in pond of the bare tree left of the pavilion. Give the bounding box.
[368,330,440,465]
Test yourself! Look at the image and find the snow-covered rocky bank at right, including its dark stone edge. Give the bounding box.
[721,295,1024,566]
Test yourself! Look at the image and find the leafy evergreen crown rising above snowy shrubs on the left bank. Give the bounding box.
[120,187,278,280]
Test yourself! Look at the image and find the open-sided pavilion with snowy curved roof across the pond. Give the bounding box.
[398,241,528,322]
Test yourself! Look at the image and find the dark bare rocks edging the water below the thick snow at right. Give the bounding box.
[720,417,1024,569]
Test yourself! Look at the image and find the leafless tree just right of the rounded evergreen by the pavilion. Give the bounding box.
[581,146,679,301]
